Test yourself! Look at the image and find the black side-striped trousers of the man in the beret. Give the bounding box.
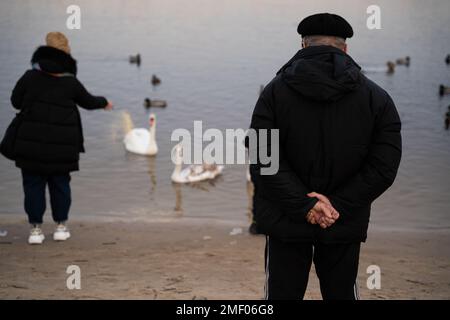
[265,237,360,300]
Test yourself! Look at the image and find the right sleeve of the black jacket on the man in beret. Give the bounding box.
[329,92,402,214]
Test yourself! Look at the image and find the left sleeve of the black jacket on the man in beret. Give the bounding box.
[249,86,317,222]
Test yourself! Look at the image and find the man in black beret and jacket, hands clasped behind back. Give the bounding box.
[251,13,401,299]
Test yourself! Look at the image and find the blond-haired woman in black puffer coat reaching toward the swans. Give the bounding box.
[11,32,112,244]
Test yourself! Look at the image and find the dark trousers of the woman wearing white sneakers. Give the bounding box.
[22,170,72,224]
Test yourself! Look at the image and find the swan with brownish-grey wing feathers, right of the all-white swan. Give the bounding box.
[171,144,224,183]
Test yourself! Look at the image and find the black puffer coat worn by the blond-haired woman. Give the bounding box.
[11,46,107,174]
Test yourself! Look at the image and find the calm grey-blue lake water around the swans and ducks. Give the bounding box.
[0,0,450,230]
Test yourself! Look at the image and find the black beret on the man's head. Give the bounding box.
[297,13,353,39]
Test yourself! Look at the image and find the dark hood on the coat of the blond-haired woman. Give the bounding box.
[31,46,77,75]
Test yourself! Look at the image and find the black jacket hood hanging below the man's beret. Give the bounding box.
[277,46,364,101]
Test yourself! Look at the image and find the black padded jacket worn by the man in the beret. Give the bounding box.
[251,46,401,243]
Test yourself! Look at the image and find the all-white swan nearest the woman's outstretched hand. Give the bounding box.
[123,113,158,156]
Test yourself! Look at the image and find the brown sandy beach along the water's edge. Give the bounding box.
[0,218,450,299]
